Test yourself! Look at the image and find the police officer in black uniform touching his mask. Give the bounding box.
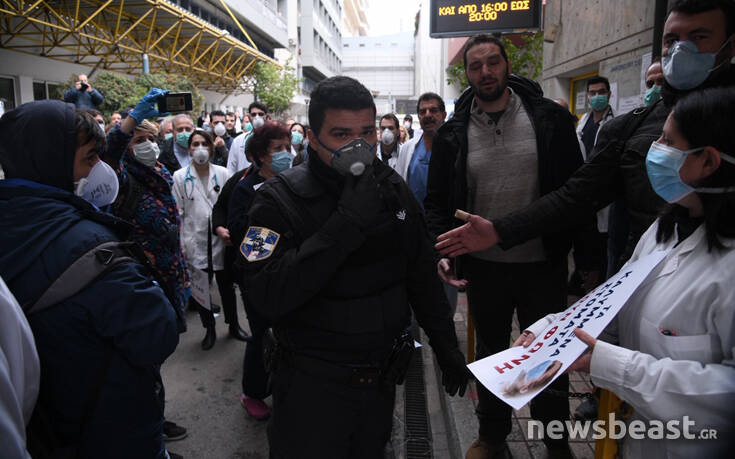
[240,76,469,458]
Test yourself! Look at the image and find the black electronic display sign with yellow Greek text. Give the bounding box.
[429,0,542,38]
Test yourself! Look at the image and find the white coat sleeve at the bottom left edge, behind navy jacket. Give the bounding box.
[0,278,41,458]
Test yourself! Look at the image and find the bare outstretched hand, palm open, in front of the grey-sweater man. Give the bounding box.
[434,214,500,258]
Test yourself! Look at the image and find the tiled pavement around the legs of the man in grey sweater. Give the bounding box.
[455,293,595,459]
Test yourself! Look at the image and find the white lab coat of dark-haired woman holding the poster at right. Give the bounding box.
[529,221,735,459]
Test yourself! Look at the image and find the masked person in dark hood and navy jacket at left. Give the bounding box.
[0,100,178,459]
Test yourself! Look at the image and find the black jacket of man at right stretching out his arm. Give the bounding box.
[493,102,669,268]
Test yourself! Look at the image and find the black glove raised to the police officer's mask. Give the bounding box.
[337,167,385,230]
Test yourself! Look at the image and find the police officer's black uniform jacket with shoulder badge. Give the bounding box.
[245,151,457,364]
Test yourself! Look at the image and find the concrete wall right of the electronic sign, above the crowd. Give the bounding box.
[541,0,655,113]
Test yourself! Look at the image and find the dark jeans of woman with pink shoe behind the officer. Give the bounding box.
[240,284,270,400]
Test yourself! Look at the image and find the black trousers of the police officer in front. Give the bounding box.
[268,363,395,459]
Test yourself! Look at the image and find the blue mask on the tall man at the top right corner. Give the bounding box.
[661,40,729,91]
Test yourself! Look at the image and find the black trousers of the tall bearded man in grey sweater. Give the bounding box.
[462,257,569,443]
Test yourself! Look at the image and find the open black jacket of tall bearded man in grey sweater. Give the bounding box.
[424,75,599,269]
